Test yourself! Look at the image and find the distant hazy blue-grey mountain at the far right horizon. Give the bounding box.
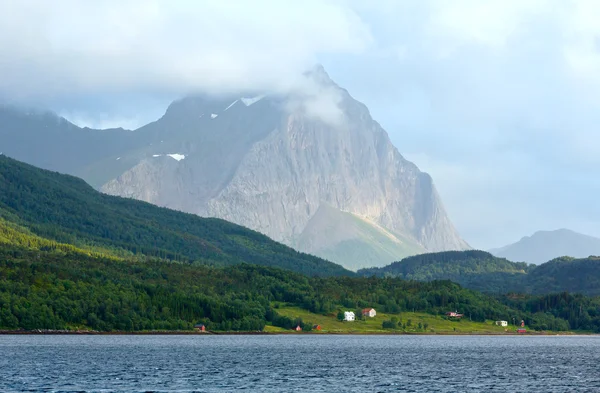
[490,229,600,264]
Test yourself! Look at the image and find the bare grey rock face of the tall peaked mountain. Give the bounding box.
[102,69,469,268]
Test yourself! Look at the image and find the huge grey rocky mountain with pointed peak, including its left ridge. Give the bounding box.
[0,67,469,269]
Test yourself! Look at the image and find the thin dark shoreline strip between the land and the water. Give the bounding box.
[0,329,600,337]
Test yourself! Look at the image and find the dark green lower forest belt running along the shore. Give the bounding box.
[0,244,600,331]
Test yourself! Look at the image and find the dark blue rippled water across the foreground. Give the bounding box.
[0,336,600,392]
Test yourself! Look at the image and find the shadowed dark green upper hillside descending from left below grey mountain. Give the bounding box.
[0,155,352,275]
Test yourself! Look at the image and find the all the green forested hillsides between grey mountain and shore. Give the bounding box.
[0,155,600,332]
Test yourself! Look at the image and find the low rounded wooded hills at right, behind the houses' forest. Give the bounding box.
[358,250,600,296]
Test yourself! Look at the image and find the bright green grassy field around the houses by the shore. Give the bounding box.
[272,306,528,334]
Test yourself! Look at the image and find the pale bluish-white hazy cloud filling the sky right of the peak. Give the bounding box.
[332,0,600,248]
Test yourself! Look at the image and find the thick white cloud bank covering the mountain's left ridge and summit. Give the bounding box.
[0,0,371,98]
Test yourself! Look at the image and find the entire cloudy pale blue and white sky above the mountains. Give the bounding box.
[0,0,600,249]
